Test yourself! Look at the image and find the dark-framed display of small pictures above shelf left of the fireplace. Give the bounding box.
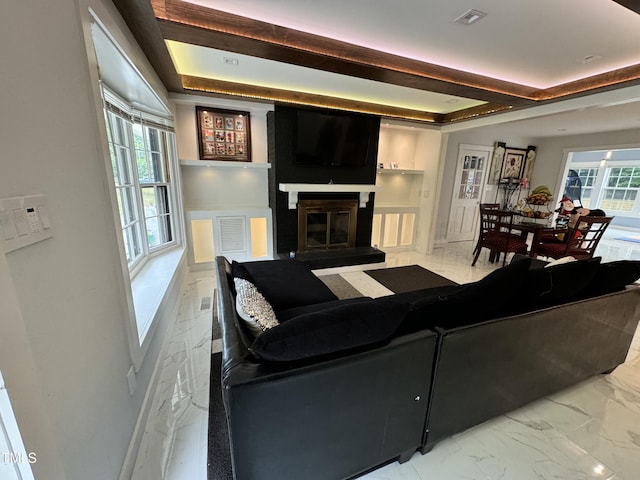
[196,106,251,162]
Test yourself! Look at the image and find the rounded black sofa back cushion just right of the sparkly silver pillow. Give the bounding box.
[251,297,408,362]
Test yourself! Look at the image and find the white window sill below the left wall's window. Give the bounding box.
[131,247,186,345]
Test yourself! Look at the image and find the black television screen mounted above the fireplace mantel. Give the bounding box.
[295,110,378,167]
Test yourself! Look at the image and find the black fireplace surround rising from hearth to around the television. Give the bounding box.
[267,105,384,264]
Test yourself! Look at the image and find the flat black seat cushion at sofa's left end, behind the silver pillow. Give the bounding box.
[232,260,338,312]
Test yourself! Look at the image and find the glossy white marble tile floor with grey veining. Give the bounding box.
[132,232,640,480]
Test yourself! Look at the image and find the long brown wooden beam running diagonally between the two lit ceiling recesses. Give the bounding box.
[152,0,537,106]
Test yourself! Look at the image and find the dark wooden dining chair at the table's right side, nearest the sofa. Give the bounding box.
[531,216,614,260]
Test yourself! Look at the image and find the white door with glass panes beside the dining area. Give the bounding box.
[447,145,493,242]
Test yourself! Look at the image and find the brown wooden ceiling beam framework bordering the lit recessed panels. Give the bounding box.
[113,0,640,124]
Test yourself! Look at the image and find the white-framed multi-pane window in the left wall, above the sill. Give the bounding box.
[105,94,175,270]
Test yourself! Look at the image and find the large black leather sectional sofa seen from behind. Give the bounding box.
[216,253,640,480]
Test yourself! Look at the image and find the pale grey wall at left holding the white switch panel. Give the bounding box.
[0,0,180,480]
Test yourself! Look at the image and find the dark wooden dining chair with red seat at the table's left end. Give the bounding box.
[471,206,528,266]
